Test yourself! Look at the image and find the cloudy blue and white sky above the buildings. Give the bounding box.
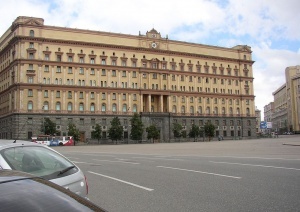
[0,0,300,115]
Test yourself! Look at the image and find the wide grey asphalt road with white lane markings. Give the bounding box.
[54,135,300,212]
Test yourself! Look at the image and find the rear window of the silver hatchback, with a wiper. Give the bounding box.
[0,146,78,180]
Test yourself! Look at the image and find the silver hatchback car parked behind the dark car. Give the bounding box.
[0,139,88,198]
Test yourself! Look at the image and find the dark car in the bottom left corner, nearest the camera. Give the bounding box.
[0,170,105,212]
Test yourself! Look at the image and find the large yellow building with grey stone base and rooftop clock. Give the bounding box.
[0,17,256,142]
